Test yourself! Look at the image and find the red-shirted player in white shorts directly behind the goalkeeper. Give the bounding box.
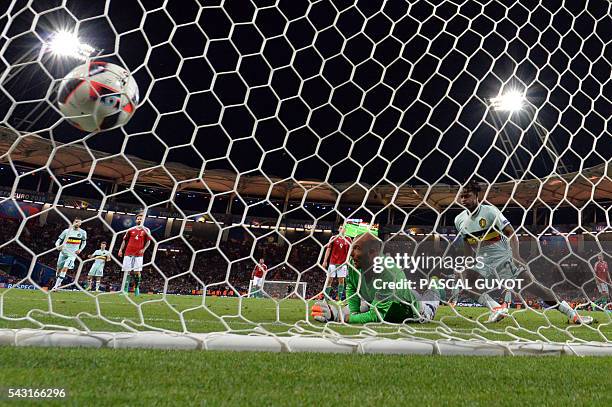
[323,226,351,301]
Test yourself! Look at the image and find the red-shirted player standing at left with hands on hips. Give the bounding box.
[118,214,151,296]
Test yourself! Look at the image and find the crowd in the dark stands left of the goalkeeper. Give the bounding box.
[0,219,325,296]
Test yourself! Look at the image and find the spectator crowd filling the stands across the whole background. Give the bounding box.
[0,219,595,303]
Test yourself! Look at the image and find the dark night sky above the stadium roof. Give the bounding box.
[0,0,612,191]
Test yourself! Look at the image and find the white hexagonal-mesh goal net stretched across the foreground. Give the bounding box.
[0,0,612,355]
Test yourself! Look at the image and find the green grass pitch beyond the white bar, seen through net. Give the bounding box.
[0,289,612,342]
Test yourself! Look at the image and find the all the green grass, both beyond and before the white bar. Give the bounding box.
[0,290,612,406]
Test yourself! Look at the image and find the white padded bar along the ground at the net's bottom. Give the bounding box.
[0,329,612,356]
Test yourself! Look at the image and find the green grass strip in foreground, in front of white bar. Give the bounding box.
[0,347,612,407]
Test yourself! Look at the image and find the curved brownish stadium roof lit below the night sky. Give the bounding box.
[0,127,612,209]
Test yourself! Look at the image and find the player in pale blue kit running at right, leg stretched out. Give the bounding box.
[455,181,593,324]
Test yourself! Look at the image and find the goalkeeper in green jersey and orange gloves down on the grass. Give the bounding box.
[311,233,440,324]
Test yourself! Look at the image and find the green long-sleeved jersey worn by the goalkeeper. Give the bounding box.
[346,259,420,324]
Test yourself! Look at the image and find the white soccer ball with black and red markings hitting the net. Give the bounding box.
[58,61,138,132]
